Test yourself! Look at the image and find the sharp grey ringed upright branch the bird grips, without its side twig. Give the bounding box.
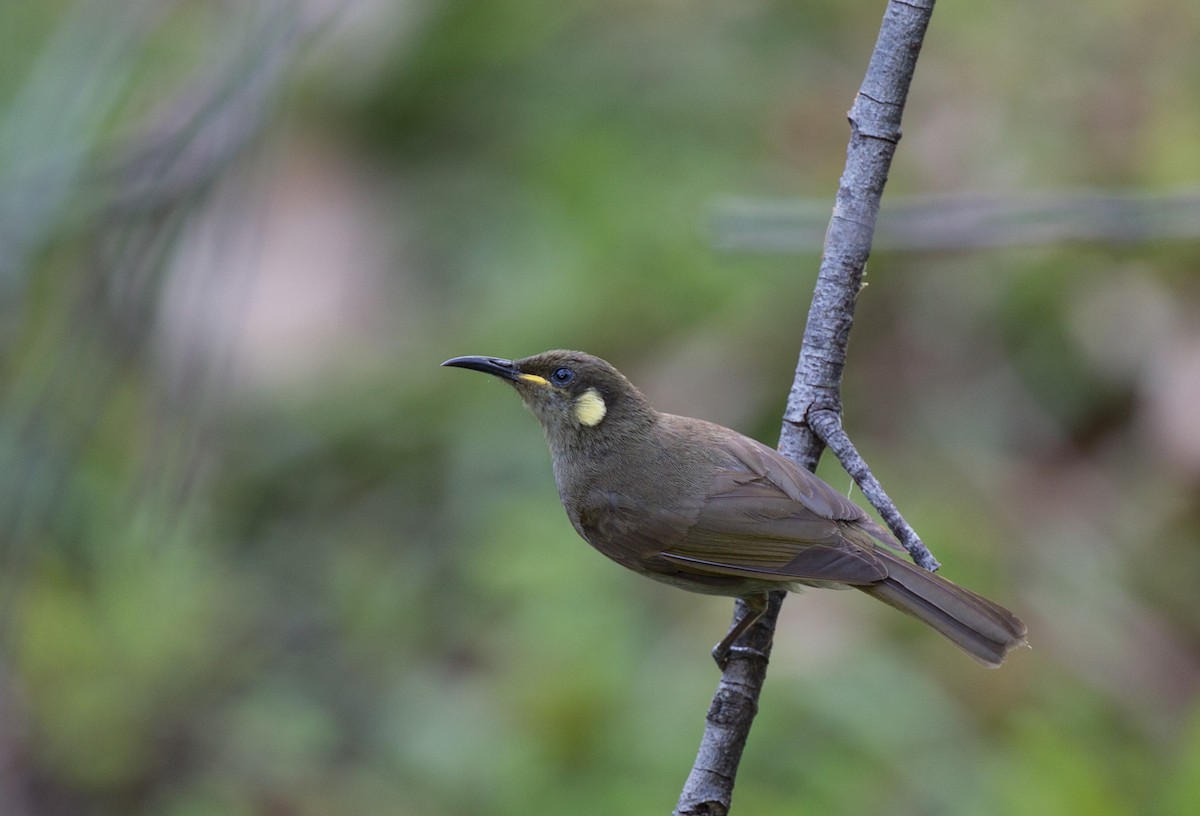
[674,0,936,816]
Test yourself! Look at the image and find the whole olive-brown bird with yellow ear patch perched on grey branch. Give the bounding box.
[442,350,1026,667]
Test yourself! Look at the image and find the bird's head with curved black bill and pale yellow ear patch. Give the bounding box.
[442,350,654,448]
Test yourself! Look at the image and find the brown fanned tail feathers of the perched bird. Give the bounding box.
[856,548,1028,668]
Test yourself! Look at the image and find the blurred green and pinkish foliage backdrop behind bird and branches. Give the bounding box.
[0,0,1200,816]
